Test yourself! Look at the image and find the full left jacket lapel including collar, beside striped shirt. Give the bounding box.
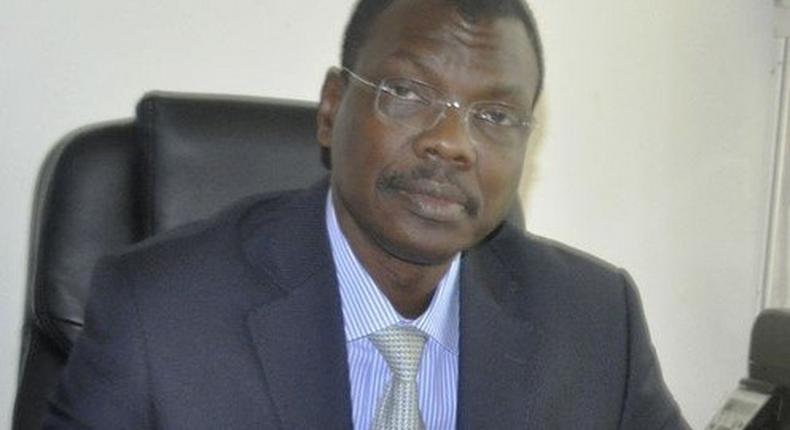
[243,182,351,429]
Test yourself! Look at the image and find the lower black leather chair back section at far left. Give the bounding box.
[13,121,143,429]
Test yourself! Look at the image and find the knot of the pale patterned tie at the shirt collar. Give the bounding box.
[369,325,427,380]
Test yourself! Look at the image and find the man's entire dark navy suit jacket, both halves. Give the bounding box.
[45,180,687,430]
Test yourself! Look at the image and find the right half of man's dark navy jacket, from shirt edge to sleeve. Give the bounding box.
[459,225,688,429]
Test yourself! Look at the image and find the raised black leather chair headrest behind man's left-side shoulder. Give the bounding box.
[137,92,327,234]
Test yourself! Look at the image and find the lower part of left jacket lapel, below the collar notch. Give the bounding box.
[248,270,351,429]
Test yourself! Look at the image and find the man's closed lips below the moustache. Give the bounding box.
[399,180,467,222]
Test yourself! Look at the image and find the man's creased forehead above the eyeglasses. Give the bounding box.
[356,0,539,103]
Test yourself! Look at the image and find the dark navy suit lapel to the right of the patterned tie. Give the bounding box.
[458,235,541,429]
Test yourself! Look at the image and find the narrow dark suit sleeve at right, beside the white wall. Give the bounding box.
[620,273,690,430]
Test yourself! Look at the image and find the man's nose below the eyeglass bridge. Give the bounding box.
[414,108,477,170]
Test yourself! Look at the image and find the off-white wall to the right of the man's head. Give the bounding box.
[528,0,776,428]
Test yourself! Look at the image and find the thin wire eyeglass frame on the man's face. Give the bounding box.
[334,67,538,146]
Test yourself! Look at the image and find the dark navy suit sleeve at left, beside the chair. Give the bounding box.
[43,258,154,429]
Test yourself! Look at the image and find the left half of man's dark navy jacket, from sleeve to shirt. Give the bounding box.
[45,184,350,430]
